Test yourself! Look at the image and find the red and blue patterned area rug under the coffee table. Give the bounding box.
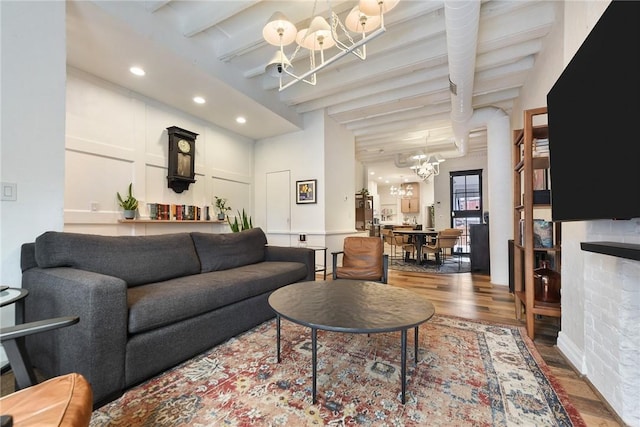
[91,315,585,427]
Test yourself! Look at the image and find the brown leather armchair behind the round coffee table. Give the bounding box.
[331,236,389,283]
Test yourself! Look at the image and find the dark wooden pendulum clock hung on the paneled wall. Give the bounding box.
[167,126,198,193]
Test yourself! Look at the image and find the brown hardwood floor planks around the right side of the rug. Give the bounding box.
[382,270,624,427]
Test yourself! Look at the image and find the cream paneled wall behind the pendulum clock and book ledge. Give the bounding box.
[64,69,254,235]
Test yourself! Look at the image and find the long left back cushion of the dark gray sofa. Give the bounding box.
[35,231,200,287]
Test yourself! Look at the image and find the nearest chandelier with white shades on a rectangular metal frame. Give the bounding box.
[262,0,400,91]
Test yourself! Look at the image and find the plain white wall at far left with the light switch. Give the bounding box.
[0,1,66,340]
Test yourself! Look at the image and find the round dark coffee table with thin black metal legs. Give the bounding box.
[269,279,435,404]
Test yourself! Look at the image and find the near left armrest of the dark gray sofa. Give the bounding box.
[22,267,128,401]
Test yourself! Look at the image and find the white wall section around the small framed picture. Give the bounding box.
[255,111,355,260]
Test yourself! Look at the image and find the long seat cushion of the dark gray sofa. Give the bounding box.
[127,261,307,334]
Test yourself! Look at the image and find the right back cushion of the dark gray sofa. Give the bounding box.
[191,228,267,273]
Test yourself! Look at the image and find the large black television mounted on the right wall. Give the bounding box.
[547,0,640,221]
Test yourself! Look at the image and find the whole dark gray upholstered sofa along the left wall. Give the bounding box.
[21,228,315,407]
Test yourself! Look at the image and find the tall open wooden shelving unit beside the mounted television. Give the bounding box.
[513,107,562,339]
